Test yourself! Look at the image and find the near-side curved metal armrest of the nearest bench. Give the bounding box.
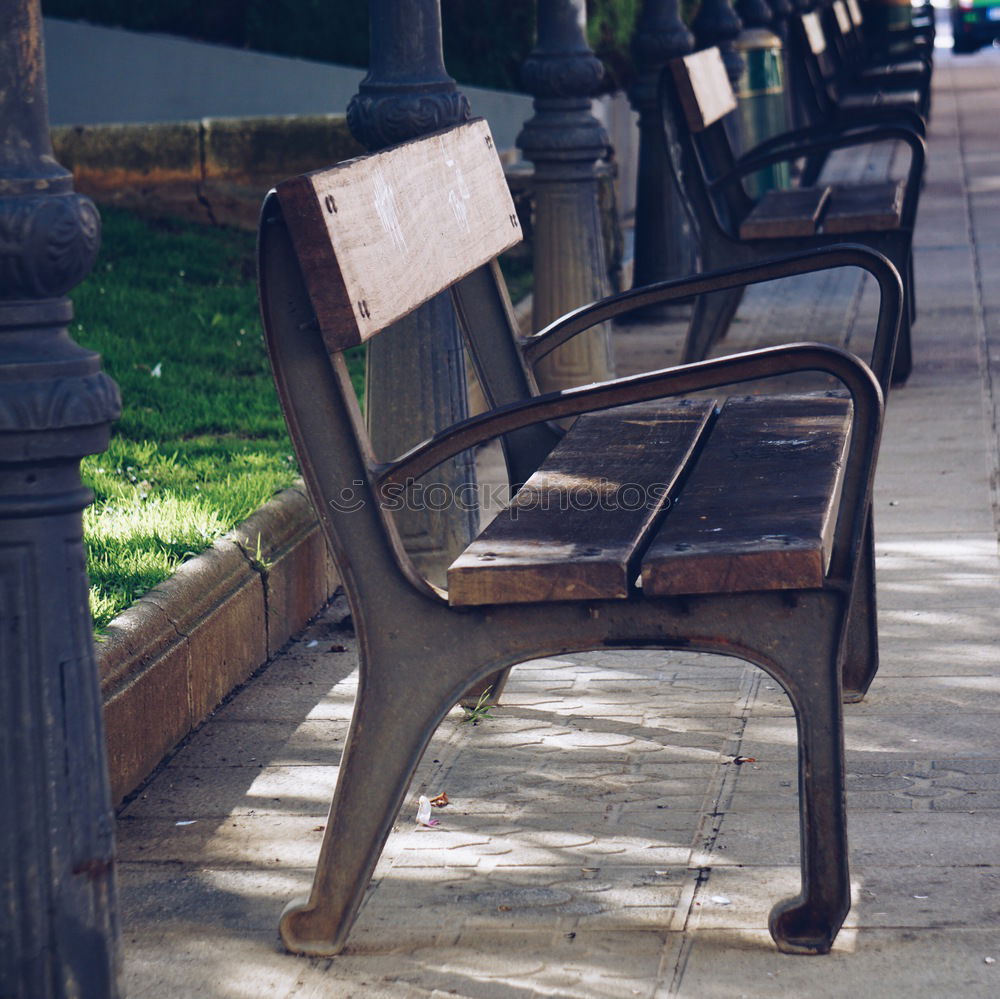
[374,343,884,575]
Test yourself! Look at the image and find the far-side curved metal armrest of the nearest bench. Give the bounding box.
[522,243,903,392]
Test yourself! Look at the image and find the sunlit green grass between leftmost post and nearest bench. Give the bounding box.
[72,209,363,630]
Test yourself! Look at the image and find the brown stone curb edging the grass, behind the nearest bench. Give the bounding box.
[97,486,339,804]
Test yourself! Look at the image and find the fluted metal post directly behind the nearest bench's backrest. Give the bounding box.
[347,0,478,582]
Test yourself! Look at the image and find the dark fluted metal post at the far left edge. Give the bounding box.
[0,0,120,999]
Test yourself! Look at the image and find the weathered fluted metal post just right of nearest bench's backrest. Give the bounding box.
[517,0,612,389]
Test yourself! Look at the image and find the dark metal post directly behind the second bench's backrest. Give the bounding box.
[629,0,695,310]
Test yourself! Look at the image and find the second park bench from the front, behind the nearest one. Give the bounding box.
[660,48,925,382]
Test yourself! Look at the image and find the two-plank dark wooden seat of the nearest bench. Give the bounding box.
[448,395,851,606]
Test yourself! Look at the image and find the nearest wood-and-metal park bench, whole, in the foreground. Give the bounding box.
[260,121,902,954]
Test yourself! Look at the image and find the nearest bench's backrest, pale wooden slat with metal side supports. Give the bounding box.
[258,121,559,596]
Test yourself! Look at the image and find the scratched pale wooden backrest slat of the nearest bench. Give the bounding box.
[277,120,521,351]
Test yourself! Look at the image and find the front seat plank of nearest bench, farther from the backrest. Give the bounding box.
[642,396,850,596]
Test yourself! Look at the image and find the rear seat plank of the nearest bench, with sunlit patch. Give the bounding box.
[448,400,715,605]
